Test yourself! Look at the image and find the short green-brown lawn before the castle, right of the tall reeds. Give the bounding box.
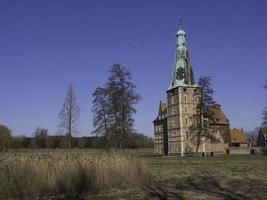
[95,152,267,199]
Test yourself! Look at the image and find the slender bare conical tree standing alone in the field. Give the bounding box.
[58,85,80,150]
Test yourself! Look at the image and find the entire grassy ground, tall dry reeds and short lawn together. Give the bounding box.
[0,150,267,200]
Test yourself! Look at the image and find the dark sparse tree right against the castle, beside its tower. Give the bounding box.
[190,77,217,152]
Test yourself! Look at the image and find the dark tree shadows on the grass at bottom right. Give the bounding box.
[144,175,267,200]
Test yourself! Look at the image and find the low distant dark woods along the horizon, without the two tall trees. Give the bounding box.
[0,125,154,150]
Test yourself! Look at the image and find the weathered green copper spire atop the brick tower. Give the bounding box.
[169,21,196,89]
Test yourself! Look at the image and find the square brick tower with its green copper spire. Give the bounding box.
[167,27,198,156]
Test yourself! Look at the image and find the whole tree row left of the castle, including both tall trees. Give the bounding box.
[0,64,153,149]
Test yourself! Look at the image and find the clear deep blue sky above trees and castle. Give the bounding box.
[0,0,267,136]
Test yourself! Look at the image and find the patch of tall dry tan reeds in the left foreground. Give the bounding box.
[0,151,150,199]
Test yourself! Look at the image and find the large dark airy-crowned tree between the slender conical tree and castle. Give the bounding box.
[92,64,140,148]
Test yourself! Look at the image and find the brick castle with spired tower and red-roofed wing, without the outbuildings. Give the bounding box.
[153,27,230,156]
